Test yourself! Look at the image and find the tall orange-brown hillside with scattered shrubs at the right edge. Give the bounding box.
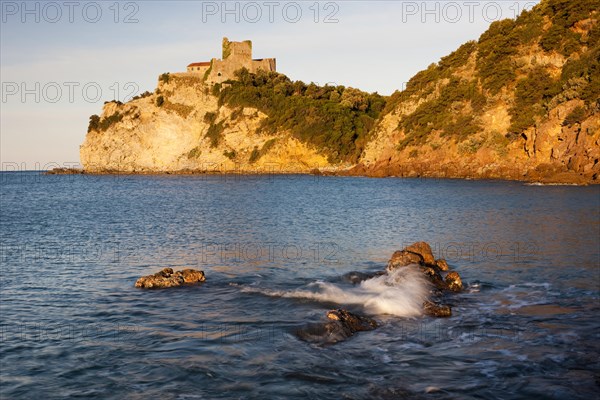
[353,1,600,183]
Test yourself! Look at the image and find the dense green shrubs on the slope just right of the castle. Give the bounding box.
[219,69,385,162]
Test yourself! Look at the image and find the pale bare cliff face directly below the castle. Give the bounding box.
[80,74,329,173]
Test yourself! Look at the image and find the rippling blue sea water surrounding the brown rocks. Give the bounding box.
[0,172,600,399]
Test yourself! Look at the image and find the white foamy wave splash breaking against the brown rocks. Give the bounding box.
[241,266,430,317]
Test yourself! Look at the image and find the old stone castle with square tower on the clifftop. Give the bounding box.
[187,37,275,83]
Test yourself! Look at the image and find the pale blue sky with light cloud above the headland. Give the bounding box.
[0,0,538,171]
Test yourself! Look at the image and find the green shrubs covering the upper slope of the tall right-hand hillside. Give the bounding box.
[386,0,600,150]
